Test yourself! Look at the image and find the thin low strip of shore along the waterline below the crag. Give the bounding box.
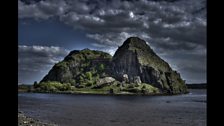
[18,84,192,96]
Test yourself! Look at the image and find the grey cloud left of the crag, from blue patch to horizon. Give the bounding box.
[18,45,68,81]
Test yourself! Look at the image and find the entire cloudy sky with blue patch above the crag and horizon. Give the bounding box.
[18,0,207,84]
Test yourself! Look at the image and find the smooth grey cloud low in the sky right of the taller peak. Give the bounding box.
[161,49,207,83]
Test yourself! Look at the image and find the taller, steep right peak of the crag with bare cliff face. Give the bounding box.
[112,37,187,94]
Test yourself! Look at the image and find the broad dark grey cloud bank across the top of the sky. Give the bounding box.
[19,0,206,46]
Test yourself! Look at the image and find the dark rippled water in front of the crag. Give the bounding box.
[18,89,207,126]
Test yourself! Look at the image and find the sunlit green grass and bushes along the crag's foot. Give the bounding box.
[32,82,160,94]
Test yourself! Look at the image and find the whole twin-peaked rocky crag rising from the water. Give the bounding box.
[36,37,187,94]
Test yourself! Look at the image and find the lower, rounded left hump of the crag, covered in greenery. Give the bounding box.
[41,49,112,85]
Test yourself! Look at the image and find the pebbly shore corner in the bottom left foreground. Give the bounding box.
[18,111,58,126]
